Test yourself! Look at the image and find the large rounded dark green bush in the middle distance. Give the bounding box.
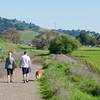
[49,35,80,54]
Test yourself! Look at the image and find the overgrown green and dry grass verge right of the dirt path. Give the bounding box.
[40,59,100,100]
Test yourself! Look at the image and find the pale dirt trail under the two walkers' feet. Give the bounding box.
[0,64,42,100]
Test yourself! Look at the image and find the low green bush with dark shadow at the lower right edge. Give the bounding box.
[70,75,100,96]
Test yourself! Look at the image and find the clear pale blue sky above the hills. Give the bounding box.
[0,0,100,33]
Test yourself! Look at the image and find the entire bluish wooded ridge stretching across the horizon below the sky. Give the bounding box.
[0,17,99,37]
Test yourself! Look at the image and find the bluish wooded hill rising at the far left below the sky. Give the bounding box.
[0,17,40,32]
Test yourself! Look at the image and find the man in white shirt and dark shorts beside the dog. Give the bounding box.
[20,51,31,83]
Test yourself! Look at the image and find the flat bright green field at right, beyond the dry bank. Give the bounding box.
[72,47,100,73]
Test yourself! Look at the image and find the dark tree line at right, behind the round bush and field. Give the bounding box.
[52,29,100,46]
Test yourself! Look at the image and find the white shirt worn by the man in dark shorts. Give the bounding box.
[21,54,30,68]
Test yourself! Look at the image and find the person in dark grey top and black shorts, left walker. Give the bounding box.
[5,51,16,83]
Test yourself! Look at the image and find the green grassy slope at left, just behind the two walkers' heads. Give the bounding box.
[0,41,31,62]
